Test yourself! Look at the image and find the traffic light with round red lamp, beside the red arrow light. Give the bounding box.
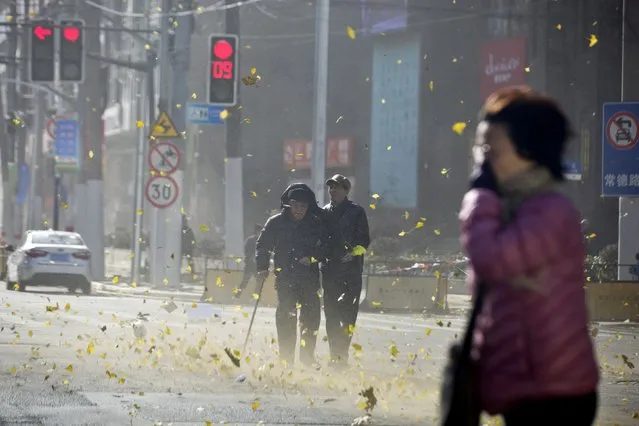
[58,20,84,82]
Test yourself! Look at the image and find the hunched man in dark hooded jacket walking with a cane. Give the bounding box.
[255,187,327,366]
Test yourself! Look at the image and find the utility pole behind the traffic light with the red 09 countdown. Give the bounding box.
[224,0,244,257]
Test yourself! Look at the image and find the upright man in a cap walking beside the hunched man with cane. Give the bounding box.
[322,174,370,368]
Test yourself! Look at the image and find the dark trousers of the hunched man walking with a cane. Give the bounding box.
[275,277,321,365]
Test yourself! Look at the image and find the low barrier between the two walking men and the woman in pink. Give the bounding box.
[364,275,448,311]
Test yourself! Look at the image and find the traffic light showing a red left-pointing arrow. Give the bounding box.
[30,21,55,82]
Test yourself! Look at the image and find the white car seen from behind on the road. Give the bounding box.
[6,230,92,294]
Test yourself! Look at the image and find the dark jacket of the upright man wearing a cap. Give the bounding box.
[324,199,371,273]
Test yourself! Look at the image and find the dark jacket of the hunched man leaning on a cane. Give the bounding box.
[255,208,328,283]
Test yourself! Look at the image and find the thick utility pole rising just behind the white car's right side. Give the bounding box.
[77,0,105,280]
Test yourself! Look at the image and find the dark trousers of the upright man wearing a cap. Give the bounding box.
[322,268,362,363]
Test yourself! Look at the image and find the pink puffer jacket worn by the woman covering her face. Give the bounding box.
[460,189,599,414]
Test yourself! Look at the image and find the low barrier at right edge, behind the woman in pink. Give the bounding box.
[586,281,639,322]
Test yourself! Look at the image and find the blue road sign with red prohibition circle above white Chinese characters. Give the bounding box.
[601,102,639,197]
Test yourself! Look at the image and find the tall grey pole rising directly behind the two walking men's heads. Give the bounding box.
[311,0,330,206]
